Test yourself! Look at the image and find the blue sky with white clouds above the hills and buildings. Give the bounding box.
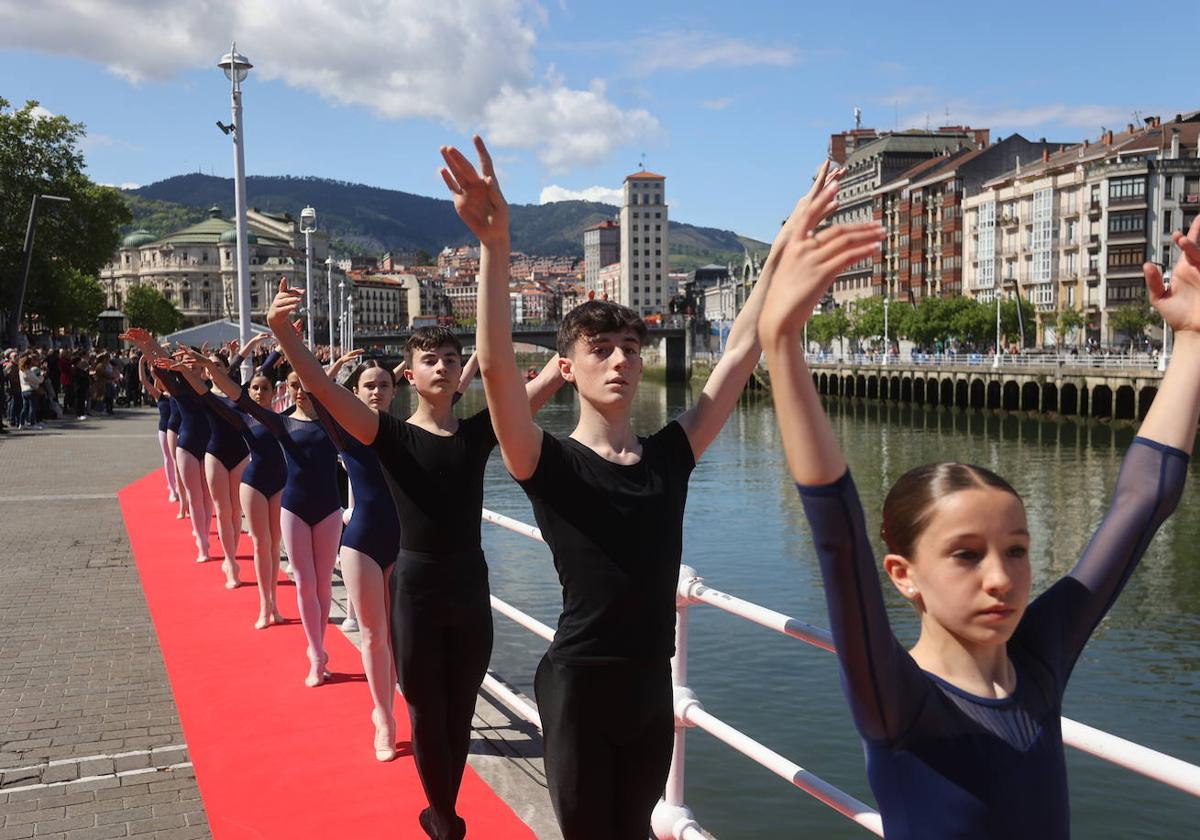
[0,0,1185,241]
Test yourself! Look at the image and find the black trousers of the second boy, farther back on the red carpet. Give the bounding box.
[391,550,492,838]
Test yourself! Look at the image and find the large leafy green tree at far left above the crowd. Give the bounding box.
[0,97,131,340]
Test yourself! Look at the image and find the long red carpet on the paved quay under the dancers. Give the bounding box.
[120,470,534,840]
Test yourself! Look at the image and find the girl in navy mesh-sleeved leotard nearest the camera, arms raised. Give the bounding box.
[760,187,1200,840]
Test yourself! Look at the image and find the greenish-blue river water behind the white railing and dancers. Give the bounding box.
[394,383,1200,840]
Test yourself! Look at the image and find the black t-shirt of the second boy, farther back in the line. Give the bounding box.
[371,409,496,554]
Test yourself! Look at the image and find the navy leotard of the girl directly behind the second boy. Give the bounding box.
[308,394,400,569]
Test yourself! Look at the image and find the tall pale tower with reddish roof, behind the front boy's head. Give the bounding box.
[617,170,671,316]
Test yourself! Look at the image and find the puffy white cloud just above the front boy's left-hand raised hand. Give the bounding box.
[484,77,661,174]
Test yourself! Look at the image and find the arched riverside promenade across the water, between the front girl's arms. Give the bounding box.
[808,354,1163,420]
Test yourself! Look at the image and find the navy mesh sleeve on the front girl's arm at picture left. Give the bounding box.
[797,472,930,742]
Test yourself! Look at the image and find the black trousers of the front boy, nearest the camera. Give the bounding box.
[534,655,674,840]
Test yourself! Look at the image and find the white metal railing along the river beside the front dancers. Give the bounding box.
[482,508,1200,840]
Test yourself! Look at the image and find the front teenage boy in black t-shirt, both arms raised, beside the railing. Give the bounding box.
[442,137,840,840]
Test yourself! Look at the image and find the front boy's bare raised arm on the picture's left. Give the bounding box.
[442,137,541,481]
